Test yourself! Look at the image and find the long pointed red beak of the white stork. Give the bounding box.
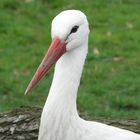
[25,37,66,95]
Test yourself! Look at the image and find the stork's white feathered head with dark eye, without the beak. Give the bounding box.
[51,10,89,51]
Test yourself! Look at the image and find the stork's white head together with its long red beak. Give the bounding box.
[25,10,89,94]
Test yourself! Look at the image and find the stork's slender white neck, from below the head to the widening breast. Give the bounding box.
[46,44,87,109]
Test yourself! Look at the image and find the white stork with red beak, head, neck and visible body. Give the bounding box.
[25,10,140,140]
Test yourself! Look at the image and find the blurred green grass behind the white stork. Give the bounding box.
[0,0,140,119]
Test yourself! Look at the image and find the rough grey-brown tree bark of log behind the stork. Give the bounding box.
[0,107,140,140]
